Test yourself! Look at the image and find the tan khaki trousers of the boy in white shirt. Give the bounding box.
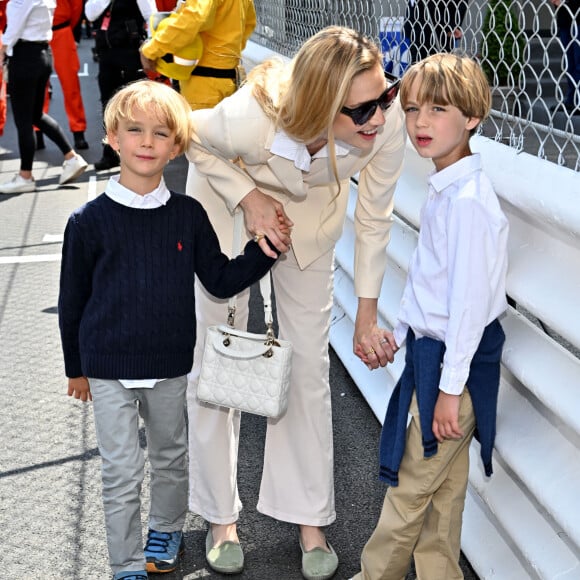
[353,389,475,580]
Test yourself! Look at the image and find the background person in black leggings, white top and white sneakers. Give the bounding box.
[0,0,87,193]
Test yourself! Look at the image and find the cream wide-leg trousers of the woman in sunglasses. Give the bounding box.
[187,251,336,526]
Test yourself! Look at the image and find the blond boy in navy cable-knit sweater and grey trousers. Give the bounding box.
[58,81,284,580]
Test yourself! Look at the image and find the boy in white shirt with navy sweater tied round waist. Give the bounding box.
[348,54,508,580]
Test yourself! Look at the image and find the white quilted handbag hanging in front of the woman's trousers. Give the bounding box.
[197,211,292,418]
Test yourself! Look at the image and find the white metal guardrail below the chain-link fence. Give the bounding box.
[245,43,580,580]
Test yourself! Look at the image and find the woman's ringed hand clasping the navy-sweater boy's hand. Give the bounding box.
[240,189,294,258]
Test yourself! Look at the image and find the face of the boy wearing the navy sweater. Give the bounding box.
[107,109,179,195]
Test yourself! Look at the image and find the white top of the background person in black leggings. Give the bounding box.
[2,0,56,56]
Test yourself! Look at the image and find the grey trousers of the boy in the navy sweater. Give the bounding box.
[89,376,188,574]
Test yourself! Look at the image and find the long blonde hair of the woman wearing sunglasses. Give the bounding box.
[248,26,382,192]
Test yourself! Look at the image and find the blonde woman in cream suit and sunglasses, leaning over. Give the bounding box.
[187,27,405,579]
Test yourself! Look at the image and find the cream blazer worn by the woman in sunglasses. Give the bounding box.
[187,86,406,298]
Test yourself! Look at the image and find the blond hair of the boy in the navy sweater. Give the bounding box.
[103,80,193,154]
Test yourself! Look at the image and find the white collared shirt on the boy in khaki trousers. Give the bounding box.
[394,154,508,395]
